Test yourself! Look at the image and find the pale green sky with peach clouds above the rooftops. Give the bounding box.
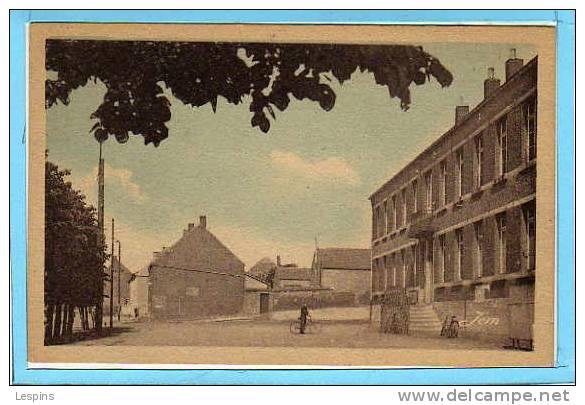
[47,43,537,271]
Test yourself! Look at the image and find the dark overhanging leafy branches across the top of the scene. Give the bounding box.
[45,40,453,146]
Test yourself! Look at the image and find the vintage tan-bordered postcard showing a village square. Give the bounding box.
[28,23,556,368]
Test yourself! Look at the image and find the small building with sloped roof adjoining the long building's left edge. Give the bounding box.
[312,248,372,302]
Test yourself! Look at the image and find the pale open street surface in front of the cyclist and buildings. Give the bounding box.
[75,319,501,349]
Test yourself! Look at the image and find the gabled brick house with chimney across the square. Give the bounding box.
[148,216,245,319]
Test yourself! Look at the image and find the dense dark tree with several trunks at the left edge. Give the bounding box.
[44,161,106,342]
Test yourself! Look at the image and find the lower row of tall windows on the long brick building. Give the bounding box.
[372,200,536,292]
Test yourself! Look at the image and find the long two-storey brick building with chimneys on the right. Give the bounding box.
[370,57,538,340]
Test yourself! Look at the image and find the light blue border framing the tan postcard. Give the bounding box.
[10,10,575,385]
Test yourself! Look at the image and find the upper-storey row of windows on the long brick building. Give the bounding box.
[372,97,536,239]
